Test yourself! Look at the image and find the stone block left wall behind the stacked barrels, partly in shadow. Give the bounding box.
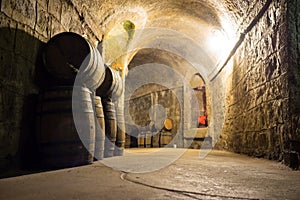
[0,0,102,170]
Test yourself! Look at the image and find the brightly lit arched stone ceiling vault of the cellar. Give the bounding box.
[82,0,245,79]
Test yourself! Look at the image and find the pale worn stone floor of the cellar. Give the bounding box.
[0,148,300,200]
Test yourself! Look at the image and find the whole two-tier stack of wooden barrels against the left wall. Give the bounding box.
[36,32,125,168]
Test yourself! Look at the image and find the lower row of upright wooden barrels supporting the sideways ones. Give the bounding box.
[36,86,125,168]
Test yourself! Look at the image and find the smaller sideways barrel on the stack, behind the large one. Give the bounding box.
[96,67,123,99]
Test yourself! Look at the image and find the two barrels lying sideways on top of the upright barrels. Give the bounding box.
[42,32,124,99]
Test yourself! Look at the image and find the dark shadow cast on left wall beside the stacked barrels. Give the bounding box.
[0,28,53,177]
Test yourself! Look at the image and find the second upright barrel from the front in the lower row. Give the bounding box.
[94,96,105,160]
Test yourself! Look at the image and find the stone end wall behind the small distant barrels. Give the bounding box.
[125,85,183,147]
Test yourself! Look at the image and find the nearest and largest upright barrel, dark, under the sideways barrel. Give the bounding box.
[36,86,95,168]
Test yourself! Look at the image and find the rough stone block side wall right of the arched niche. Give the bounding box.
[219,0,290,159]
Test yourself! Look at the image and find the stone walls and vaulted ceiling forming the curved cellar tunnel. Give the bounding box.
[0,0,300,175]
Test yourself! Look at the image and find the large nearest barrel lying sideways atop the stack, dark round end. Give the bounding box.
[43,32,105,90]
